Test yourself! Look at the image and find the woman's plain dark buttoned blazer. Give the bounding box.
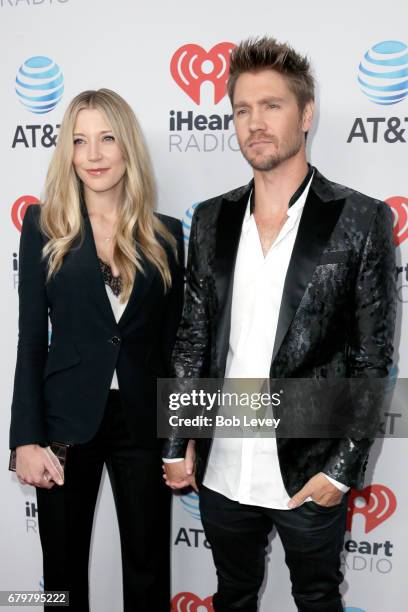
[10,205,184,448]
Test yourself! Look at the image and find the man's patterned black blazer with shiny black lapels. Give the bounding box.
[164,170,396,495]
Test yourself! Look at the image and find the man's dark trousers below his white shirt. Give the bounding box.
[200,487,347,612]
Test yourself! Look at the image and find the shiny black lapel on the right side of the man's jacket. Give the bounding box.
[272,171,344,362]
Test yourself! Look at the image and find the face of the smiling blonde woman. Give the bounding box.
[72,108,126,193]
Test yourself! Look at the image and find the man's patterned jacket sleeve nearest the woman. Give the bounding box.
[163,209,210,459]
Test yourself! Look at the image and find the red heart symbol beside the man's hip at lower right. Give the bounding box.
[347,485,397,533]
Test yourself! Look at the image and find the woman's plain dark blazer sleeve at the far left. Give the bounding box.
[10,205,48,448]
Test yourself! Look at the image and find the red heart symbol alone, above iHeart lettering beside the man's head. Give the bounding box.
[170,42,236,104]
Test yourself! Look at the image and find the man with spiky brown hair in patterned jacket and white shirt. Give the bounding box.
[164,38,395,612]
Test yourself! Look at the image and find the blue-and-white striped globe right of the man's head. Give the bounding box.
[358,40,408,105]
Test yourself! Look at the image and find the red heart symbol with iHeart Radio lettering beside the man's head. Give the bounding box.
[169,42,238,153]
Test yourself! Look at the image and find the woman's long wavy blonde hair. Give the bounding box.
[40,89,176,301]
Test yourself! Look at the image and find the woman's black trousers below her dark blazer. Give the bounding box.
[37,391,170,612]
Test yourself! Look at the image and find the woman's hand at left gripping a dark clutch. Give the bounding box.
[16,444,64,489]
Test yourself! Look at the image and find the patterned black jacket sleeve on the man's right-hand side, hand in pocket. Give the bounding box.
[323,203,396,487]
